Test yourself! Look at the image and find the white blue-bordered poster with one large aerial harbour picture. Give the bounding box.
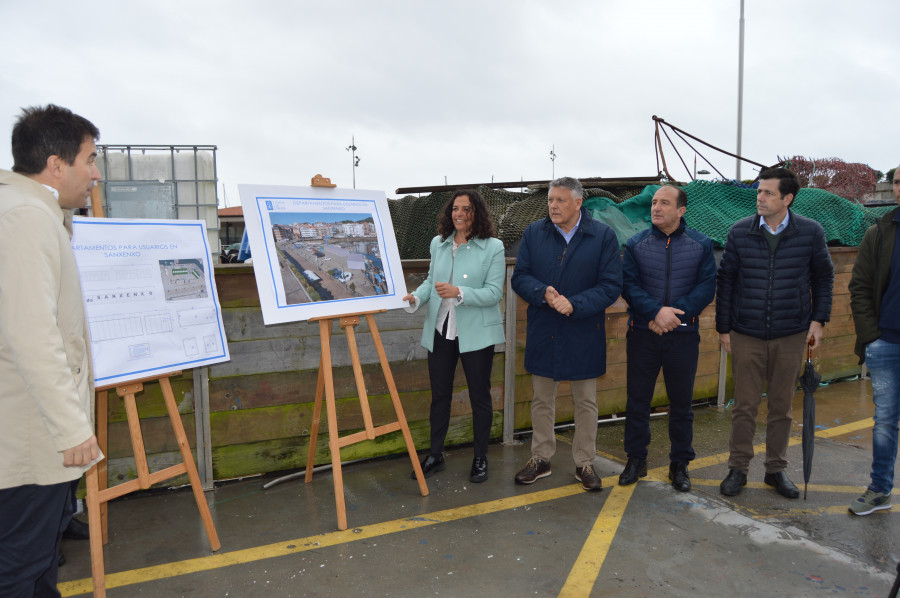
[238,185,406,324]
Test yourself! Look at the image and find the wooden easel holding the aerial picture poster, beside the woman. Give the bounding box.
[306,309,428,530]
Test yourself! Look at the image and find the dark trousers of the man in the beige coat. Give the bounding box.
[0,482,72,598]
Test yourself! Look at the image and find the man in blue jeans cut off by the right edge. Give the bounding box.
[850,169,900,515]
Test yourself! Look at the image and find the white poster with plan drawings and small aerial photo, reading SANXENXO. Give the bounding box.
[72,217,229,386]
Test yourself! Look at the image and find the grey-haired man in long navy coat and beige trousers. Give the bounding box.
[512,177,622,490]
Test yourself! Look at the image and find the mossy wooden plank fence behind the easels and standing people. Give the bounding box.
[96,248,859,485]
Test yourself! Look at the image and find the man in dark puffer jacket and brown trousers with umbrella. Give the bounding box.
[716,168,834,498]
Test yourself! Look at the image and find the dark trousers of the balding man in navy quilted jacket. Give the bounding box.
[625,330,700,463]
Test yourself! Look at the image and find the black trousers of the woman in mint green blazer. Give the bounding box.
[428,330,494,457]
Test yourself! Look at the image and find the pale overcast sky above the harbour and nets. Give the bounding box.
[0,0,900,205]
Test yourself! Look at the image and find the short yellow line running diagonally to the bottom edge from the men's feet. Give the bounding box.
[559,484,637,598]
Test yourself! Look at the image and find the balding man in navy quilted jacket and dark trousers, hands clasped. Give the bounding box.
[619,185,716,492]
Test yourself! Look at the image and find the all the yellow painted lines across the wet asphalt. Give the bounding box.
[57,418,874,596]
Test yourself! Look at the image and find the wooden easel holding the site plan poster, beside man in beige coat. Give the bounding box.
[85,187,222,598]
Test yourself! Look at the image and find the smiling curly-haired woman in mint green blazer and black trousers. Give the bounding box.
[403,190,506,483]
